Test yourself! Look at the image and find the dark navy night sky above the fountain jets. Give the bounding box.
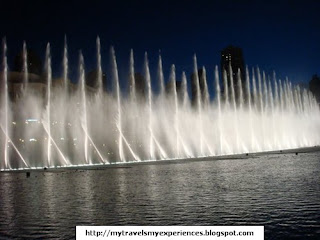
[0,0,320,91]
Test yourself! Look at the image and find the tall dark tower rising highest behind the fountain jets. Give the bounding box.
[220,45,245,101]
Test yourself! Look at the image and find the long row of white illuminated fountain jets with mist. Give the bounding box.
[0,38,320,171]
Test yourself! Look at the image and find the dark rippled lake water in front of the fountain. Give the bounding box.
[0,153,320,239]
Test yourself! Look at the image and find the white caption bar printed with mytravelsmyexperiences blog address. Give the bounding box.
[76,226,264,240]
